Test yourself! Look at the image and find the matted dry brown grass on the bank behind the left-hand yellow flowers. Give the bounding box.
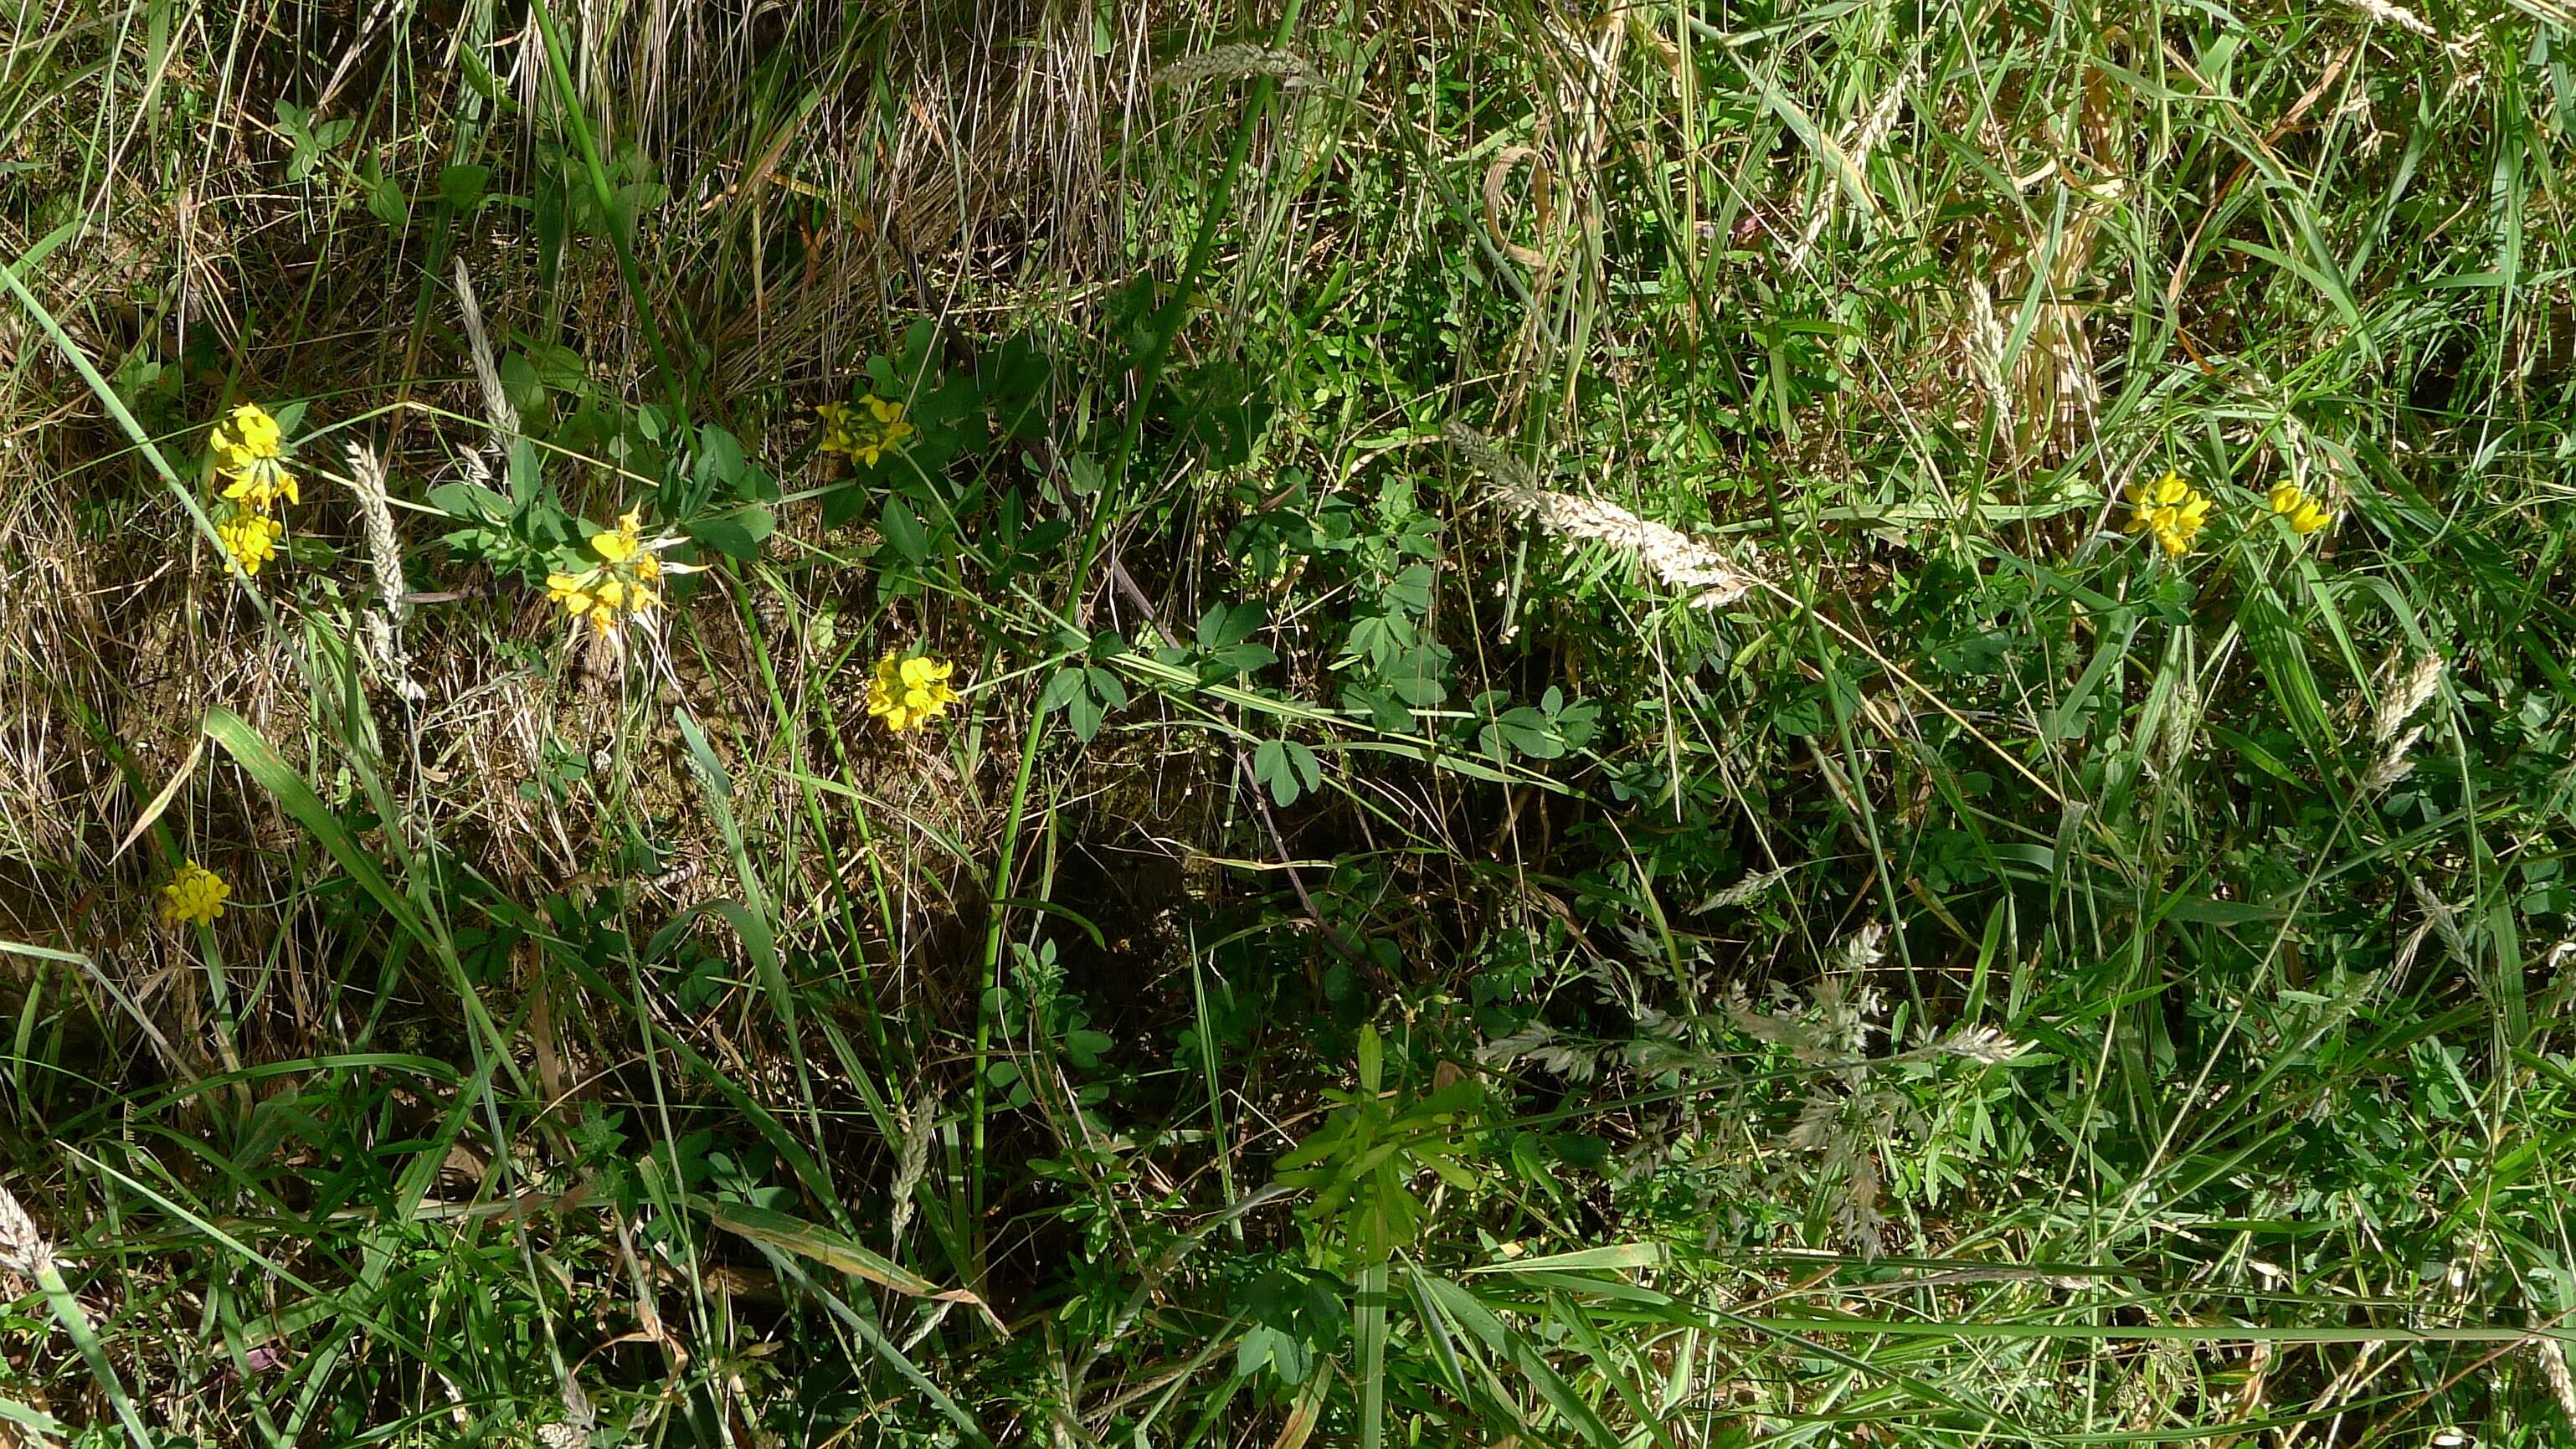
[0,3,1216,1091]
